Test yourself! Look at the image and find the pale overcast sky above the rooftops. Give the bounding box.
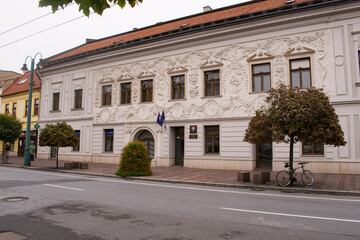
[0,0,248,73]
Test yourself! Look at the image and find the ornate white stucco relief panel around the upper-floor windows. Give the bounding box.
[94,31,335,123]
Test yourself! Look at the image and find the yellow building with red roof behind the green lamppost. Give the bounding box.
[0,72,41,157]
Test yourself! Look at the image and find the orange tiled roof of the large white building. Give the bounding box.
[46,0,312,63]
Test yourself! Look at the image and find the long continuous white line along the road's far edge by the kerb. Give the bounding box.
[0,167,360,202]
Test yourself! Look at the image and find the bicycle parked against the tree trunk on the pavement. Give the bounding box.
[276,162,314,187]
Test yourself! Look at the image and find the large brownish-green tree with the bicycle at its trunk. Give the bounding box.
[244,85,346,172]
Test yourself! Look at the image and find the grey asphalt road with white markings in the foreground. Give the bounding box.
[0,167,360,240]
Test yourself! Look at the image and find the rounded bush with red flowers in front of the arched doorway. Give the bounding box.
[116,141,152,177]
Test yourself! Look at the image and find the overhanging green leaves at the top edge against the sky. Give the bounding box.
[39,0,143,16]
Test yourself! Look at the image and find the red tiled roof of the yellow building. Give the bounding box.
[0,72,41,97]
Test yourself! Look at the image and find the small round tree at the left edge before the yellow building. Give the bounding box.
[0,114,22,159]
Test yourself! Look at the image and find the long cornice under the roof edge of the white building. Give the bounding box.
[41,0,360,73]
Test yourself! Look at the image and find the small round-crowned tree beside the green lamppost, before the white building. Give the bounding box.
[39,122,79,168]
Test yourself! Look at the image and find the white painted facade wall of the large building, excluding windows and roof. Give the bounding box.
[38,2,360,174]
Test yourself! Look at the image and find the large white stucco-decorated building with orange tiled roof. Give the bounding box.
[38,0,360,174]
